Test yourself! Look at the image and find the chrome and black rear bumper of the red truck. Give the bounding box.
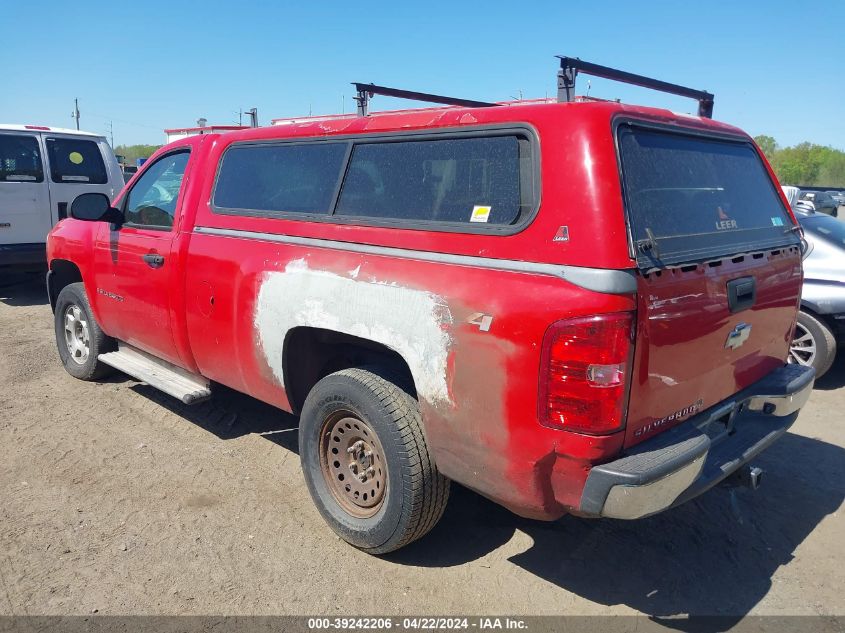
[579,365,815,519]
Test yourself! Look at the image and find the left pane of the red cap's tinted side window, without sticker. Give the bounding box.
[214,142,349,213]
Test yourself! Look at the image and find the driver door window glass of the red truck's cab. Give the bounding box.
[124,151,190,229]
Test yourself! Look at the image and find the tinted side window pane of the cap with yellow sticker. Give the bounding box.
[335,136,533,225]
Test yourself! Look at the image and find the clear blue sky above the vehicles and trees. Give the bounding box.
[0,0,845,149]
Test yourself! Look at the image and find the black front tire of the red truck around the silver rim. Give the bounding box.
[53,283,116,380]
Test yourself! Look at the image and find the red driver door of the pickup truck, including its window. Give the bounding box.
[92,148,190,365]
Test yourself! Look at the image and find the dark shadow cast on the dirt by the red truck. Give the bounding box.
[132,384,845,630]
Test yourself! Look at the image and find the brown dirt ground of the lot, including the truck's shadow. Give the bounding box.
[0,277,845,616]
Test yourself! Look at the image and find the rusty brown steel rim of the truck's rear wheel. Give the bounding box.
[320,411,387,519]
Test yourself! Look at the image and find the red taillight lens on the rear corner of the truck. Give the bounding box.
[539,312,634,435]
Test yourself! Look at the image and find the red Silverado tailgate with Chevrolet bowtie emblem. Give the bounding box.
[625,246,802,446]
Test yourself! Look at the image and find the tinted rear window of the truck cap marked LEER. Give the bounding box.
[619,125,798,266]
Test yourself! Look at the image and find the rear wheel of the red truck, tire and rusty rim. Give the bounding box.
[299,368,449,554]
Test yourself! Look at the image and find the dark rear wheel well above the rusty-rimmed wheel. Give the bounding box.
[282,327,417,413]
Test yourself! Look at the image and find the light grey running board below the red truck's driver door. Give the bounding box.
[97,343,211,404]
